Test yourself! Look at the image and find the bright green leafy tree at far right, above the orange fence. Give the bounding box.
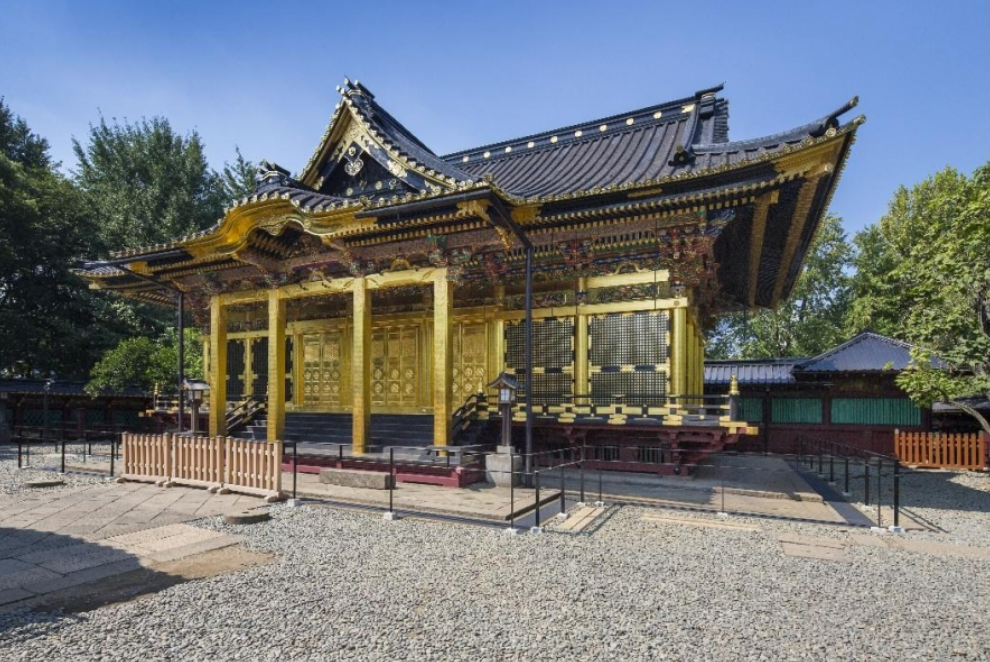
[888,163,990,433]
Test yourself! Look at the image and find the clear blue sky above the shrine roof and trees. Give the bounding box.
[0,0,990,232]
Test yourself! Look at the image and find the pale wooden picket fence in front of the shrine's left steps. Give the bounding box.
[121,433,283,499]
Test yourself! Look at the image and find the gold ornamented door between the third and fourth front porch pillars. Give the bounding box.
[371,327,419,407]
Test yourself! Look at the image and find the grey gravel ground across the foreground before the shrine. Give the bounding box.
[0,466,990,662]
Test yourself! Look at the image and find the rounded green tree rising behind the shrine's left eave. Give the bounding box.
[73,117,224,251]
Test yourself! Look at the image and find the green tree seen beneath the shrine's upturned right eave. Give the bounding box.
[706,214,852,358]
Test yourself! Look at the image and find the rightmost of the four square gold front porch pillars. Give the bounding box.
[433,269,454,446]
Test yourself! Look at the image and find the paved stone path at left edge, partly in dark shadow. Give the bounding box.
[0,483,262,605]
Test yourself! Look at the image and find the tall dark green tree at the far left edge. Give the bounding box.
[0,100,106,377]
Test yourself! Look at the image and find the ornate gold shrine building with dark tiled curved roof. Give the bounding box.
[80,81,864,470]
